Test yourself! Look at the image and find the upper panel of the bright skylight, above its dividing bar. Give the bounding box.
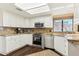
[15,3,46,10]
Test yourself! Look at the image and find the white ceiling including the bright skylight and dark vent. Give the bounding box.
[0,3,74,17]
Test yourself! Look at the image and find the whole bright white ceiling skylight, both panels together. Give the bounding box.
[15,3,50,14]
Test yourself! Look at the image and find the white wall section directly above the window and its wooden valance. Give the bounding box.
[52,4,74,15]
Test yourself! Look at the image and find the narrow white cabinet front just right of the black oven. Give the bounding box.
[45,35,54,49]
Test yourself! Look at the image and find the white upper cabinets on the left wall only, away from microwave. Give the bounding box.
[3,12,27,27]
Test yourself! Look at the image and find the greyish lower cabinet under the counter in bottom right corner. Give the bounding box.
[68,41,79,56]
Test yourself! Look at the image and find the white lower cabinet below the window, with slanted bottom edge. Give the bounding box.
[54,36,68,55]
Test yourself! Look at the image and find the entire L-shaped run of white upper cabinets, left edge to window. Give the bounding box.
[0,11,53,28]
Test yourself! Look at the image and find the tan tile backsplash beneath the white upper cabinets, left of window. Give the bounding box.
[0,27,52,35]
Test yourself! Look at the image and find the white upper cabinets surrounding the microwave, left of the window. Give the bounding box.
[29,15,53,28]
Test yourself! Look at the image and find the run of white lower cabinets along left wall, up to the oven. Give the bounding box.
[6,34,32,53]
